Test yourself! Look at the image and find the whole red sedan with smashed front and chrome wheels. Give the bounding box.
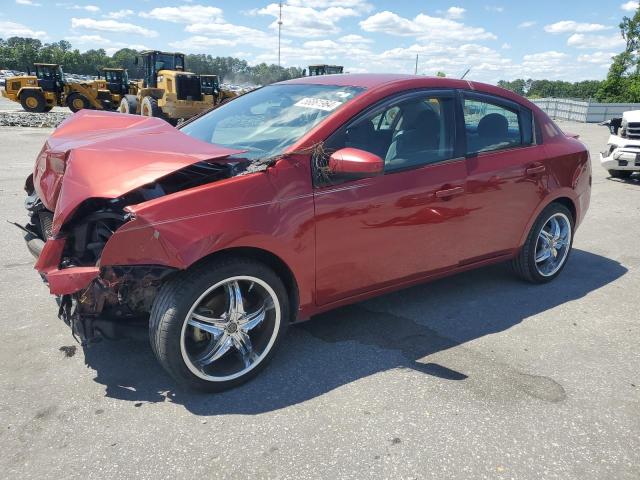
[25,75,591,391]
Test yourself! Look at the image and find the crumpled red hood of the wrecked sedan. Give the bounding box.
[33,110,241,234]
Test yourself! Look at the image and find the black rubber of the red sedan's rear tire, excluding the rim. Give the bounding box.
[512,202,575,283]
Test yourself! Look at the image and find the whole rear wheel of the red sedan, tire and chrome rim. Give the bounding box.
[512,203,575,283]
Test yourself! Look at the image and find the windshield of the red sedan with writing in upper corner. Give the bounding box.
[181,81,363,159]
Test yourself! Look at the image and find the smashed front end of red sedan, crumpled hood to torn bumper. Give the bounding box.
[20,111,245,345]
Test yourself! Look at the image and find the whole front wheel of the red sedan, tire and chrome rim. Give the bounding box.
[149,257,290,392]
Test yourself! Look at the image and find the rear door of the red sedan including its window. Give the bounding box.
[461,92,548,263]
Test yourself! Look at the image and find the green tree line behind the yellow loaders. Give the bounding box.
[0,37,304,85]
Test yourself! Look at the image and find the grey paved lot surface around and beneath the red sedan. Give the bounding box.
[0,124,640,480]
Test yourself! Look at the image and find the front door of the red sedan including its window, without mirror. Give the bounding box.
[314,91,466,304]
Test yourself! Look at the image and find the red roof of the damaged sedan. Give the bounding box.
[279,73,536,109]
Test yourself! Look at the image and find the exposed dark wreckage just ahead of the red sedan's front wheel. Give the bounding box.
[58,265,175,346]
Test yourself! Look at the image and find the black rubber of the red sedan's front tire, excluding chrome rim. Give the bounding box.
[149,257,290,392]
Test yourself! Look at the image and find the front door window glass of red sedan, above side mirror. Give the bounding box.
[325,93,455,181]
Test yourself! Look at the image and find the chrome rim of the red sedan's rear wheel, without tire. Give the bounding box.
[535,212,571,277]
